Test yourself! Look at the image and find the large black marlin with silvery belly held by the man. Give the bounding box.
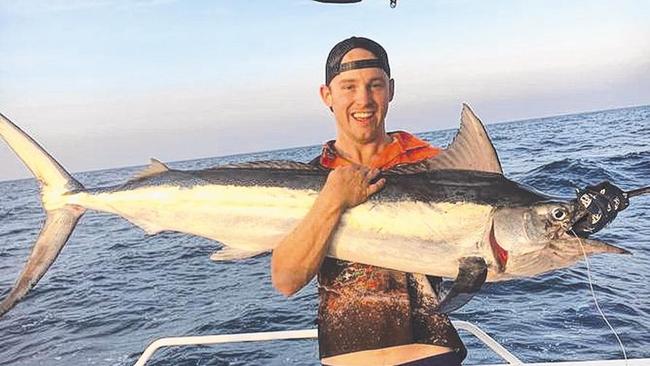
[0,105,644,315]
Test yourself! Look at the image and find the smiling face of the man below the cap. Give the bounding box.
[321,48,393,144]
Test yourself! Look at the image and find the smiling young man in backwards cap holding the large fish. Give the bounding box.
[271,37,466,365]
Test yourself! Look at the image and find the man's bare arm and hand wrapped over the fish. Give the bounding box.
[271,165,385,296]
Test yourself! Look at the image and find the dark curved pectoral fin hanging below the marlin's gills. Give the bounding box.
[436,257,487,313]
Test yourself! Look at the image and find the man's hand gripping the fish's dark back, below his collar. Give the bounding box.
[321,165,386,210]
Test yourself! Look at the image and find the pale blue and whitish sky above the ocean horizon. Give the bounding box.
[0,0,650,180]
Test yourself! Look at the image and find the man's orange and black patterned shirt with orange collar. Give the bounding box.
[311,131,467,358]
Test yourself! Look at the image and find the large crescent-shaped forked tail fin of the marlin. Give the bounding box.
[0,114,85,316]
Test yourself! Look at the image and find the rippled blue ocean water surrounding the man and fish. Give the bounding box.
[0,106,650,365]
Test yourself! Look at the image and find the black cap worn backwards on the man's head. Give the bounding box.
[325,37,390,85]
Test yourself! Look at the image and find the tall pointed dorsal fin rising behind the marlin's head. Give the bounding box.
[427,103,503,174]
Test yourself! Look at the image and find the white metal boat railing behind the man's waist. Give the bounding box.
[135,320,650,366]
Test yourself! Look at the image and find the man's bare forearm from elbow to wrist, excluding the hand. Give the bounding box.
[271,194,344,296]
